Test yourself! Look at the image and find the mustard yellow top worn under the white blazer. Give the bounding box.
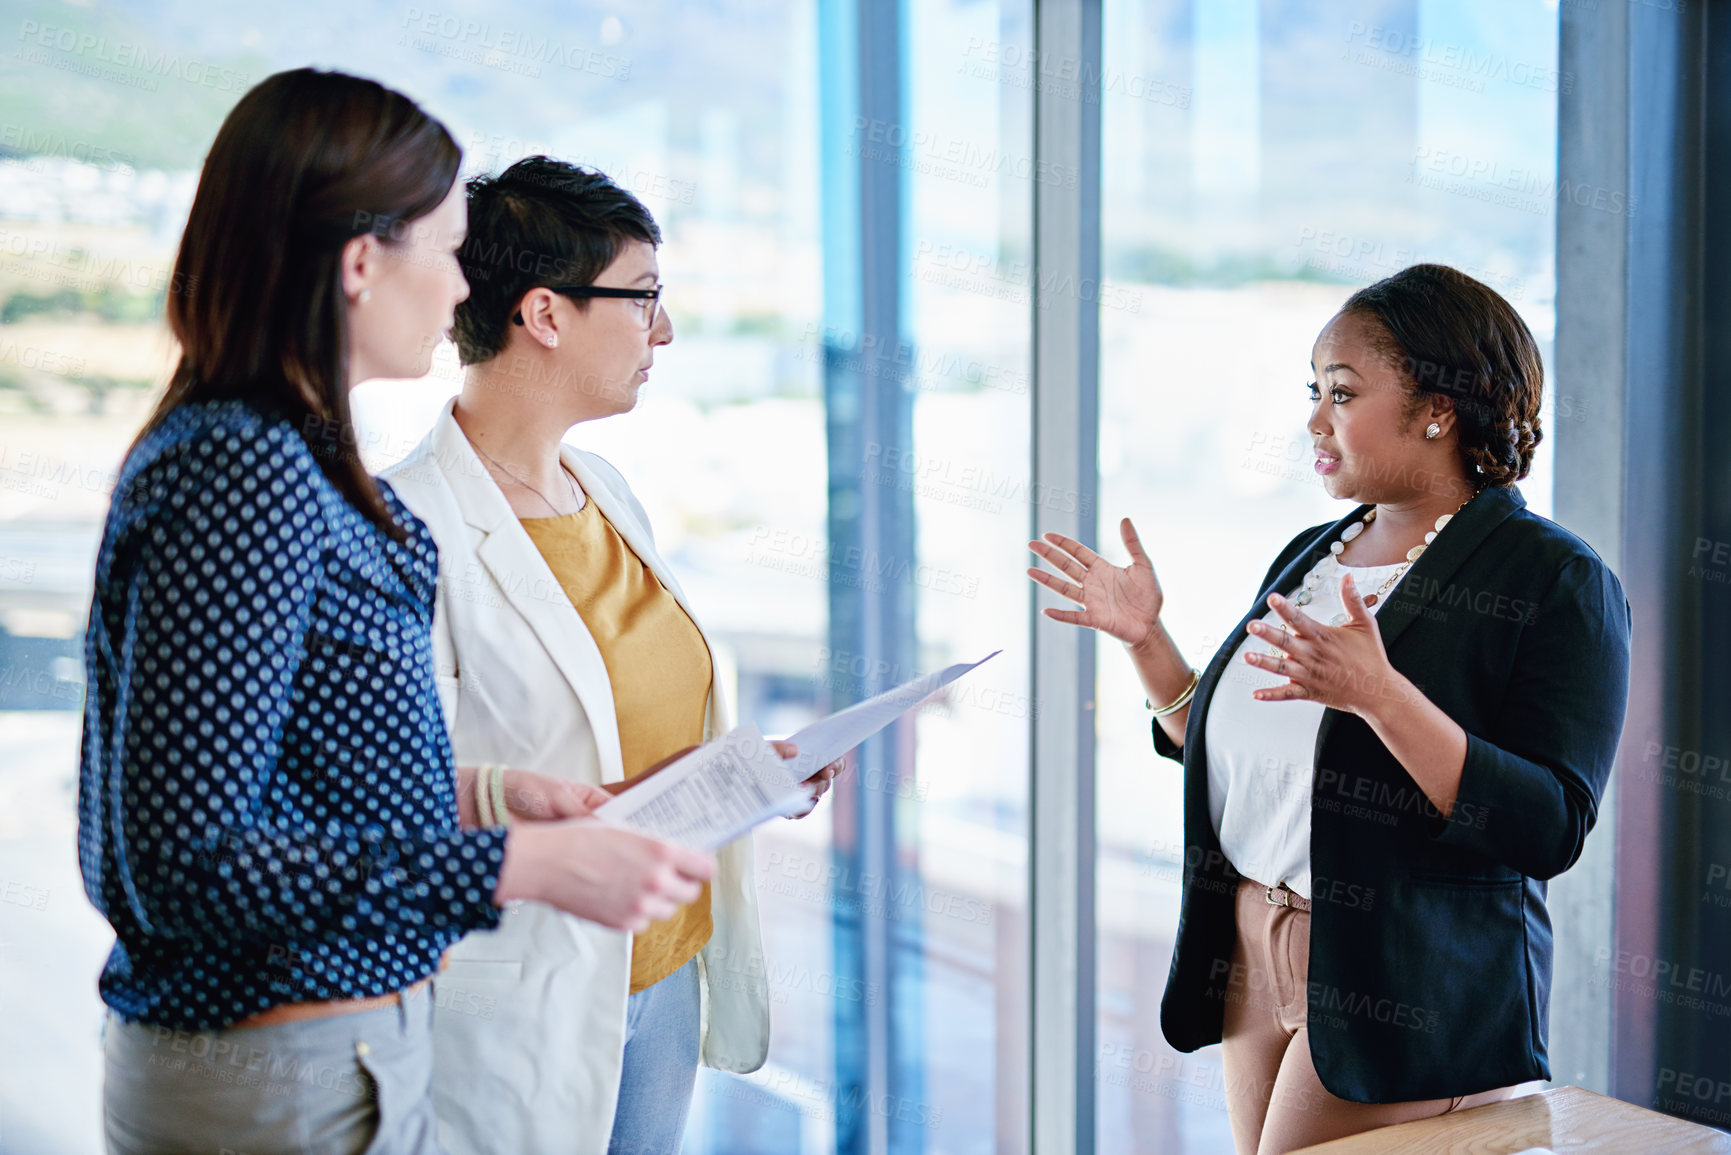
[521,499,715,994]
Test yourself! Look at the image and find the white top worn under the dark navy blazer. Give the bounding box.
[1205,554,1407,899]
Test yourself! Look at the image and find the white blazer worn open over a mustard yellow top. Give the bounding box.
[383,402,769,1155]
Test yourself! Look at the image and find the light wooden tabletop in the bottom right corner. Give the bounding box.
[1293,1087,1731,1155]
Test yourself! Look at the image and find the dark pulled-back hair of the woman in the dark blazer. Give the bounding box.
[1340,265,1544,487]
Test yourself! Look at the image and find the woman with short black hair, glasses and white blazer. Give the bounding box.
[386,156,836,1155]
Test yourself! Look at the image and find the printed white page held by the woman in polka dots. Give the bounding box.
[595,726,812,850]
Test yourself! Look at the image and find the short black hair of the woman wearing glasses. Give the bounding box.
[452,156,661,365]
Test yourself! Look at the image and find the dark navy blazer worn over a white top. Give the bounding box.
[1155,487,1629,1103]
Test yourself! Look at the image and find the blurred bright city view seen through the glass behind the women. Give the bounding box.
[0,0,1564,1155]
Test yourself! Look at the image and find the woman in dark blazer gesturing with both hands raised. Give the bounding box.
[1028,265,1629,1155]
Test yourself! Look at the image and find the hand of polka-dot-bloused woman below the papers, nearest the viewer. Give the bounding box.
[493,819,715,933]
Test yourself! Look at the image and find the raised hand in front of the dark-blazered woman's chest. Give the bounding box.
[1245,573,1409,715]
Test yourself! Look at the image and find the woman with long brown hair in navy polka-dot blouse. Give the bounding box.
[80,69,715,1153]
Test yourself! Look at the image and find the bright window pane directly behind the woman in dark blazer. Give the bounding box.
[1096,0,1557,1153]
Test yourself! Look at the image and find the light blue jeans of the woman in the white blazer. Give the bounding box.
[608,959,701,1155]
